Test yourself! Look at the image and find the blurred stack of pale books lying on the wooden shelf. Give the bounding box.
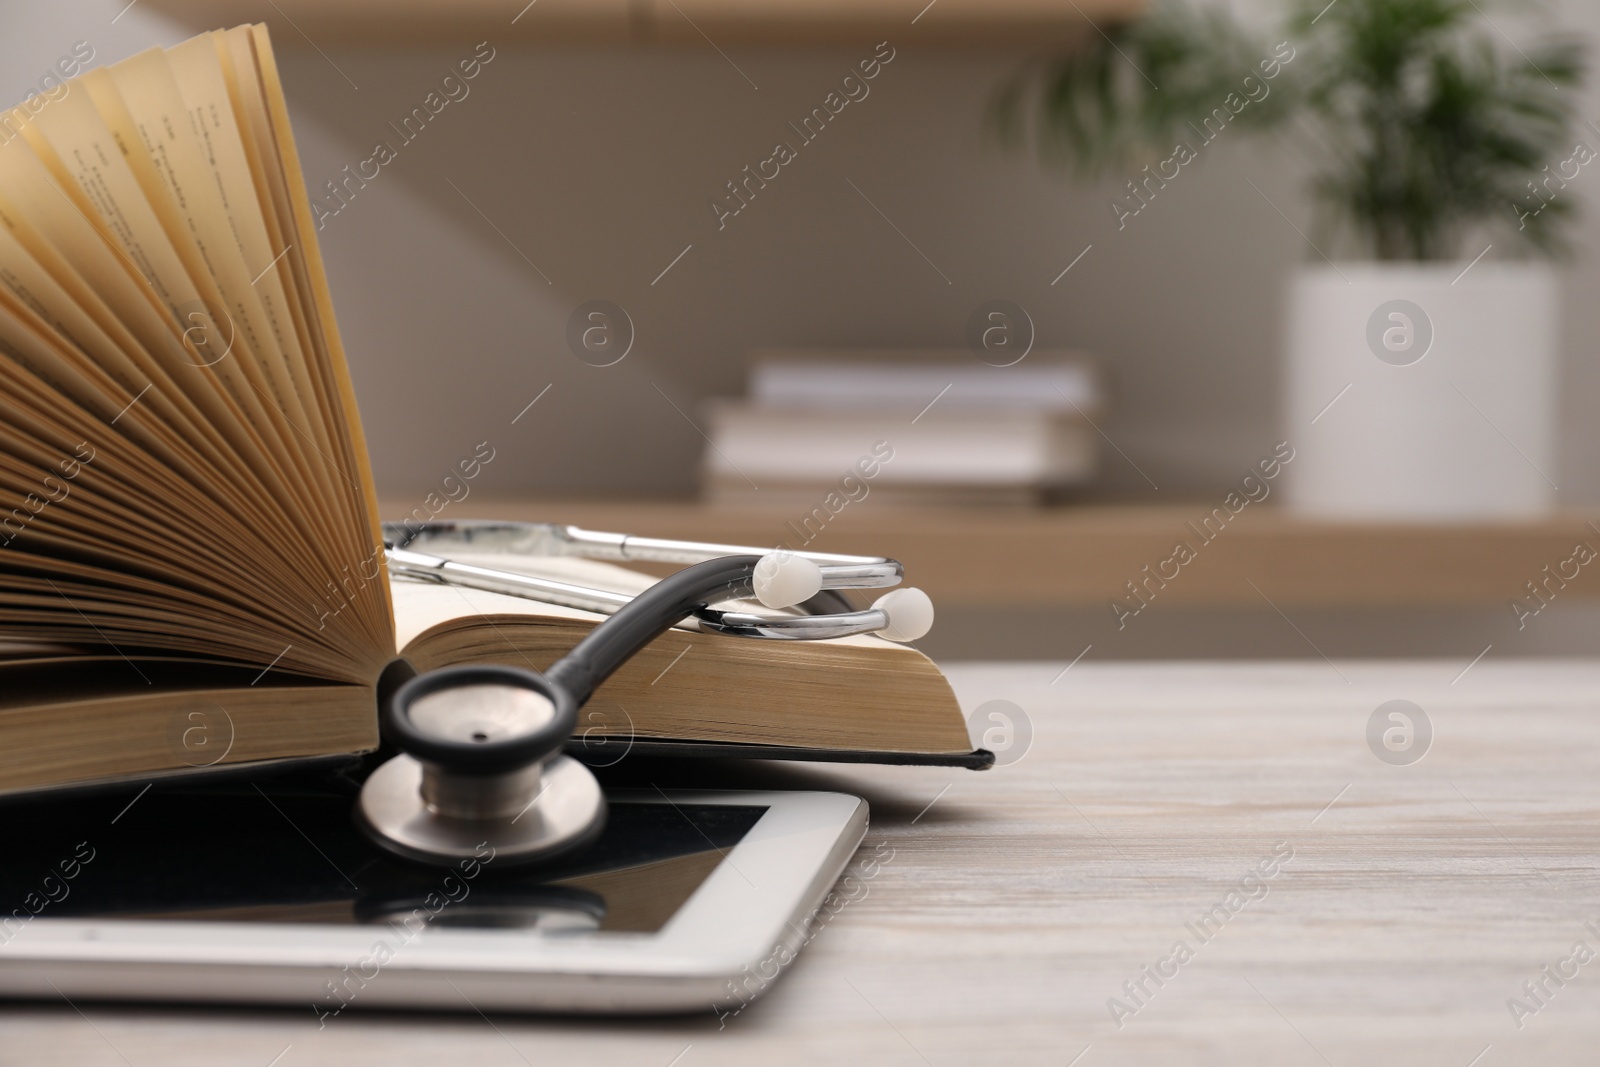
[702,350,1106,504]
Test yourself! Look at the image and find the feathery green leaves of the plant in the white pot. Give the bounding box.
[992,0,1594,259]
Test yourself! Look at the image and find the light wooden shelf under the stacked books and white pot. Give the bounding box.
[382,493,1600,608]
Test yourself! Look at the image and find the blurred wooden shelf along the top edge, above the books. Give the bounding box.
[147,0,1146,48]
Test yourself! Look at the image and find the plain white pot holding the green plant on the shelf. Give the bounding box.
[1282,262,1558,522]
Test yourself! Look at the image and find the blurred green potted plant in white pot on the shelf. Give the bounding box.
[995,0,1600,520]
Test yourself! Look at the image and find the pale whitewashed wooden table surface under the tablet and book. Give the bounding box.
[0,659,1600,1067]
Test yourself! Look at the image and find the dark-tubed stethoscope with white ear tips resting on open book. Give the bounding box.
[355,522,933,864]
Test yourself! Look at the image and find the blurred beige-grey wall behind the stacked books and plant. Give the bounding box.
[12,0,1600,502]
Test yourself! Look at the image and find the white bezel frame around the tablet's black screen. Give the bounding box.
[0,790,867,1014]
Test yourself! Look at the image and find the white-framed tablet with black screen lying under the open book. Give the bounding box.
[0,784,867,1024]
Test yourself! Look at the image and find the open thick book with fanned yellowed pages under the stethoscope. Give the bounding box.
[0,26,971,793]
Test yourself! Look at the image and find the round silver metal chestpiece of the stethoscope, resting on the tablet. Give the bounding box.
[355,665,605,865]
